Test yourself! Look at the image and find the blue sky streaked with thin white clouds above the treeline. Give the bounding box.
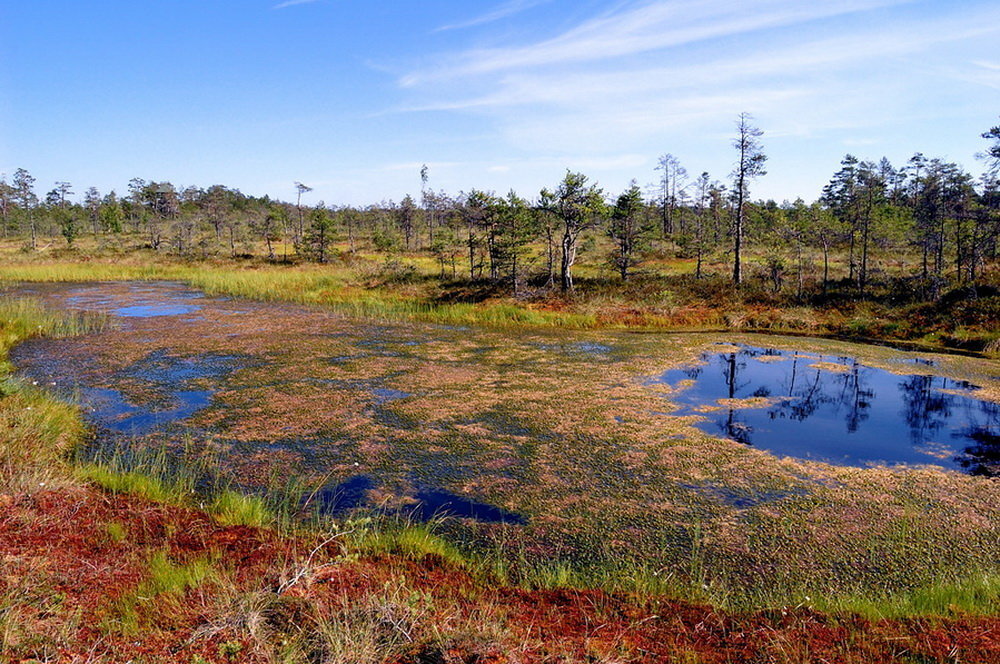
[0,0,1000,204]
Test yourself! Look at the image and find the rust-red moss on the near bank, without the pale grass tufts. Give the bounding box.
[0,489,1000,664]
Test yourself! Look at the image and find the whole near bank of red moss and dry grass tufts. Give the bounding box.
[0,489,1000,664]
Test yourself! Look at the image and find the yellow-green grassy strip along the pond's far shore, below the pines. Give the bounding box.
[0,243,997,355]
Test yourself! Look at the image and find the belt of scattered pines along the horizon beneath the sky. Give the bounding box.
[0,115,1000,297]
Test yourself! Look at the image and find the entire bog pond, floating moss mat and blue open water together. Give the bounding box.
[11,282,1000,602]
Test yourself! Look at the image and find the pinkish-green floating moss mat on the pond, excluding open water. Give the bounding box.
[1,274,997,607]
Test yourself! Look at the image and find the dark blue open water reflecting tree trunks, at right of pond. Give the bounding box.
[658,347,1000,476]
